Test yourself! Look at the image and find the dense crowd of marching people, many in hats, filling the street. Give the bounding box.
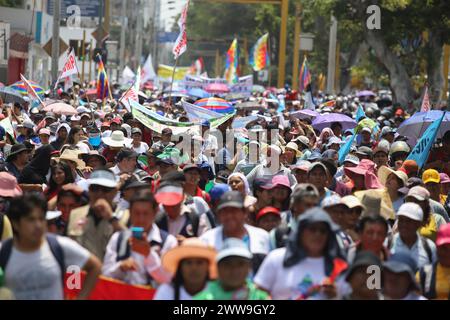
[0,88,450,300]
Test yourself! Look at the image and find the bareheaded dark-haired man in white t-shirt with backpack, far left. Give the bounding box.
[0,194,101,300]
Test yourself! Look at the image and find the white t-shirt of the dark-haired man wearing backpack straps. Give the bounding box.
[5,236,90,300]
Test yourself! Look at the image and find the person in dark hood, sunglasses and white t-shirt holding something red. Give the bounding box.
[255,208,347,300]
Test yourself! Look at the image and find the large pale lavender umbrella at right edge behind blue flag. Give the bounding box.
[397,110,450,140]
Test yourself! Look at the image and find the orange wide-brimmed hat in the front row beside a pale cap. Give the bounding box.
[162,238,217,279]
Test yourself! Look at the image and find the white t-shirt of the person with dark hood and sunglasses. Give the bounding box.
[254,248,326,300]
